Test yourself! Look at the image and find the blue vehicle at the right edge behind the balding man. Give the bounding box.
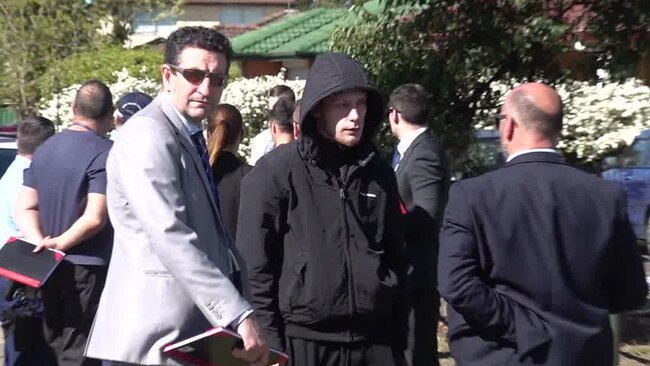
[602,130,650,250]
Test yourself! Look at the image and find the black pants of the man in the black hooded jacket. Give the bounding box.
[287,337,404,366]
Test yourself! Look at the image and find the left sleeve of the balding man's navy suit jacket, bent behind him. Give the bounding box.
[438,182,551,359]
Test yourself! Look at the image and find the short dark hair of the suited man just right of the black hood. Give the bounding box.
[389,84,430,126]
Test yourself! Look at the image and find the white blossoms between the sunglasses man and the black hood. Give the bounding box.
[221,69,305,158]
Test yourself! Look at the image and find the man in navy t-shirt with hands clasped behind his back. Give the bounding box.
[14,80,113,366]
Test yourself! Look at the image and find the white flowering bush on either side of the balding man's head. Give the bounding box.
[475,72,650,162]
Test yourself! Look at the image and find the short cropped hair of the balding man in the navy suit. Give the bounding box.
[509,90,564,139]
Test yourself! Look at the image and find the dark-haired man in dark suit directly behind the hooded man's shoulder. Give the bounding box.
[388,84,448,366]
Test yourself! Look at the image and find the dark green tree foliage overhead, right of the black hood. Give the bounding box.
[332,0,650,166]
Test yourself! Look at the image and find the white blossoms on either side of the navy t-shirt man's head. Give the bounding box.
[40,69,161,131]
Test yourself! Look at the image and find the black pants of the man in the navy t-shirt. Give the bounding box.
[42,261,107,366]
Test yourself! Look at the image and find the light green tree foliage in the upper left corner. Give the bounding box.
[0,0,181,116]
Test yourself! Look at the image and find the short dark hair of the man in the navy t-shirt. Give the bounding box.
[74,79,113,120]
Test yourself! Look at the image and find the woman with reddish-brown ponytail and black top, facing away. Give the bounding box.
[207,104,253,241]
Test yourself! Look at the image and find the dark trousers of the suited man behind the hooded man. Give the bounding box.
[404,242,440,366]
